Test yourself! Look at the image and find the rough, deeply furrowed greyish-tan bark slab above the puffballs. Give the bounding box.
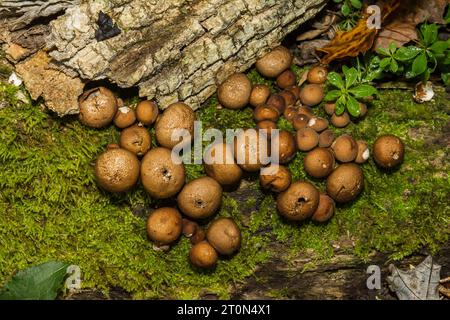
[0,0,326,114]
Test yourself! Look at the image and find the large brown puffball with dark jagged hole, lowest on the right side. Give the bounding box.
[277,181,319,221]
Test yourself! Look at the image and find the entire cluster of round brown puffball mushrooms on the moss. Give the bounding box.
[79,46,404,268]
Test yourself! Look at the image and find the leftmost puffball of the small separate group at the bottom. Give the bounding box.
[147,207,183,245]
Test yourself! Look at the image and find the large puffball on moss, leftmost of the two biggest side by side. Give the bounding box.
[95,146,139,192]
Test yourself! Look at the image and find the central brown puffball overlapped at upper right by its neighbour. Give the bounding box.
[203,143,242,186]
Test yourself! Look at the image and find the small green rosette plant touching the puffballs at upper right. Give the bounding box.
[325,66,378,117]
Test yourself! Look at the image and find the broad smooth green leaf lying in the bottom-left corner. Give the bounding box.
[0,261,69,300]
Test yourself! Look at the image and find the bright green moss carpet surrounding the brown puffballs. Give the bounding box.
[0,65,450,299]
